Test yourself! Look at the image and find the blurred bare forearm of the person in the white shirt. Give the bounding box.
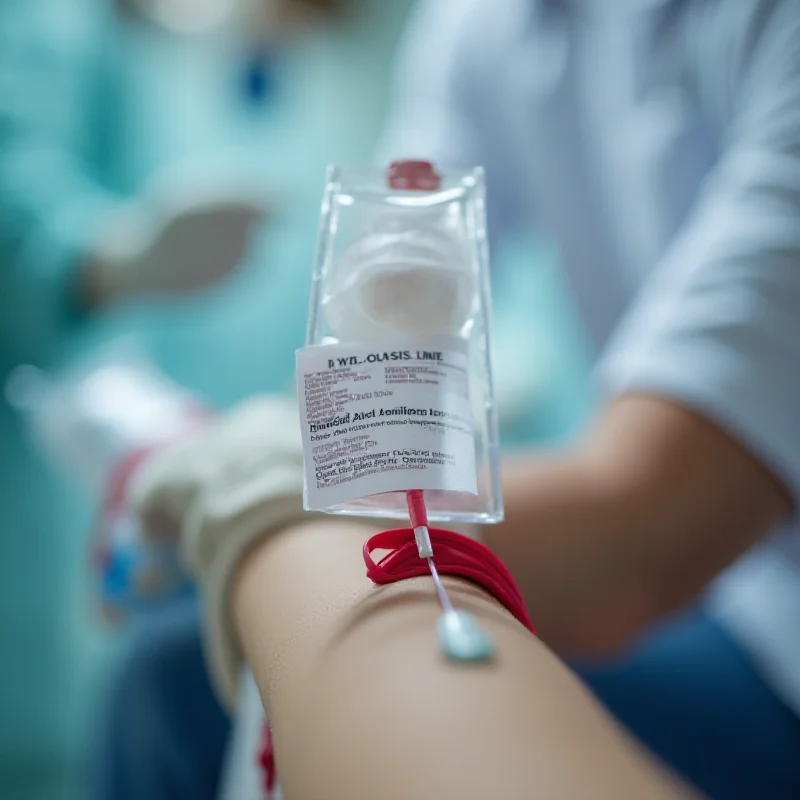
[484,394,791,655]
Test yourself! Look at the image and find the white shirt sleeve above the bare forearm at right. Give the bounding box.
[600,0,800,501]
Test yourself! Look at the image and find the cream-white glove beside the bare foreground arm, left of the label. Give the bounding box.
[128,397,309,707]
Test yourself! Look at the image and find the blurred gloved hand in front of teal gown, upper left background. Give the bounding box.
[84,161,266,306]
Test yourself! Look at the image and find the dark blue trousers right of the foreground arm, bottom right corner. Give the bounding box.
[577,611,800,800]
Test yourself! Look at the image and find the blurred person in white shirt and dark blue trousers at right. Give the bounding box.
[119,0,800,800]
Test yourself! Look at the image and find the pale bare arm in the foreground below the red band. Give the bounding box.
[232,520,692,800]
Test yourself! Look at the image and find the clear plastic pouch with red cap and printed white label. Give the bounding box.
[297,162,503,523]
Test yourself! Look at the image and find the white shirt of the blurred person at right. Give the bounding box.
[379,0,800,711]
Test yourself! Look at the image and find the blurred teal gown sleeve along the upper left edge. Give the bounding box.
[0,0,122,362]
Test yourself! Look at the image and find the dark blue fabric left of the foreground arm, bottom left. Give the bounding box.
[93,597,230,800]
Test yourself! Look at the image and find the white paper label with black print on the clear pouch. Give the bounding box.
[297,336,478,510]
